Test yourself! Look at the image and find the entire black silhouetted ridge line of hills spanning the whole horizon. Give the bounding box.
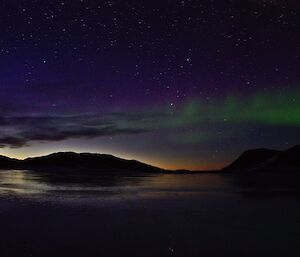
[0,145,300,173]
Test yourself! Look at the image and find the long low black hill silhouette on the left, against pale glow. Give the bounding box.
[0,152,164,172]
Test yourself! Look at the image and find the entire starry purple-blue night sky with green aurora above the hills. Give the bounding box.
[0,0,300,170]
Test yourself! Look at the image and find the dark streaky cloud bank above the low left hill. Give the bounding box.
[0,113,149,148]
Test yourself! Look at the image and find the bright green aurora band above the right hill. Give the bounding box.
[172,90,300,127]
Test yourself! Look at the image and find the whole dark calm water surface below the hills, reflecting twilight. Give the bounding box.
[0,171,300,257]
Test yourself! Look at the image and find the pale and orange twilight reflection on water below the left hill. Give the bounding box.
[0,170,227,201]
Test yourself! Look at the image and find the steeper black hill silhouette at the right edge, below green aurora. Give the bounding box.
[222,145,300,172]
